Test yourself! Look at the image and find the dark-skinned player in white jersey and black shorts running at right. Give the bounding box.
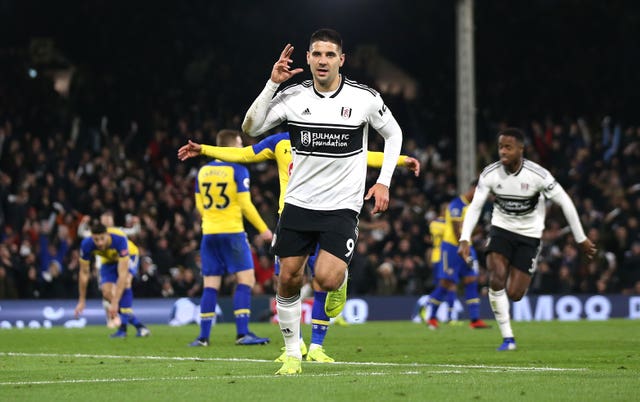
[458,128,596,351]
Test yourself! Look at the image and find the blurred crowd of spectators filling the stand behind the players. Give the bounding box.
[0,86,640,298]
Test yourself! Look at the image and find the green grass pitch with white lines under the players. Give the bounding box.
[0,319,640,402]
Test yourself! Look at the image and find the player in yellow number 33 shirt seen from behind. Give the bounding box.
[190,130,272,346]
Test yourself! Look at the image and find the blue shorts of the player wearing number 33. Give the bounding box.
[200,232,253,276]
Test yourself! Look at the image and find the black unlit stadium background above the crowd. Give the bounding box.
[0,0,640,134]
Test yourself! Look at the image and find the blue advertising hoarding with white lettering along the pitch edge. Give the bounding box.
[0,295,640,329]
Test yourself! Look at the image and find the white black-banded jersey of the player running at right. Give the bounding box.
[473,159,563,238]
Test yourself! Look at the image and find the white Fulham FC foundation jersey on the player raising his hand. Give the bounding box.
[270,76,393,212]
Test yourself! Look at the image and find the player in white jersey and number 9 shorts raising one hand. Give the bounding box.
[242,29,402,375]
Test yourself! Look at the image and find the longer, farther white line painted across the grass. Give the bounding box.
[0,352,587,371]
